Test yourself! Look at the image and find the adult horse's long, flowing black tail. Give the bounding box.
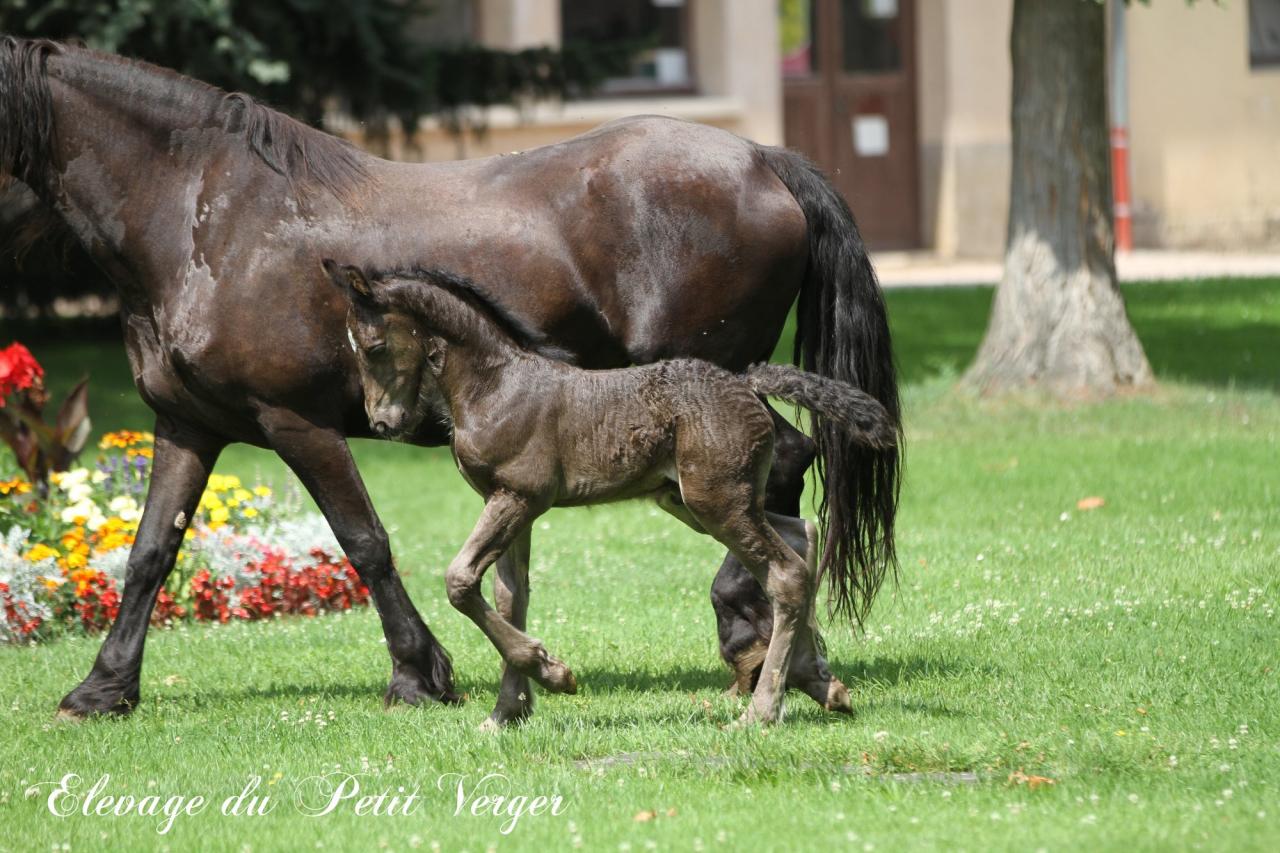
[758,146,901,622]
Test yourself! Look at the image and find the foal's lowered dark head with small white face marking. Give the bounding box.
[323,260,448,438]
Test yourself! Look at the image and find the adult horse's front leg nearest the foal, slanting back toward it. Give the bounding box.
[264,411,461,706]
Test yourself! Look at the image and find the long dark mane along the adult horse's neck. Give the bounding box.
[0,36,369,199]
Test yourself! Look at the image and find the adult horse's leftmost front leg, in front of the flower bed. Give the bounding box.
[58,416,225,719]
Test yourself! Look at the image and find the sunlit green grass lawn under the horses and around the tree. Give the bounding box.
[0,280,1280,850]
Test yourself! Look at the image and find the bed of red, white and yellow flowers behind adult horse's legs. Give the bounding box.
[0,432,369,643]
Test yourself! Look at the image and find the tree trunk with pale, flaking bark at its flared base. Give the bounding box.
[966,0,1152,394]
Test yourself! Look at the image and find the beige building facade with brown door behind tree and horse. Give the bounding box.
[366,0,1280,256]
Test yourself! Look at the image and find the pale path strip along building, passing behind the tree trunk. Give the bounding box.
[872,248,1280,287]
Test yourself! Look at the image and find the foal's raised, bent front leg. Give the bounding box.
[445,491,577,693]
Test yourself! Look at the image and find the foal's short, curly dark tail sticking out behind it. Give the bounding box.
[745,364,897,448]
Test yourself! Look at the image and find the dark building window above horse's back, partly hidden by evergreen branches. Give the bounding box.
[561,0,694,95]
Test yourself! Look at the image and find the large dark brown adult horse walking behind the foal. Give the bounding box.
[0,37,899,716]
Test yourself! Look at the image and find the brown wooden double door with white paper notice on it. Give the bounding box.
[780,0,920,248]
